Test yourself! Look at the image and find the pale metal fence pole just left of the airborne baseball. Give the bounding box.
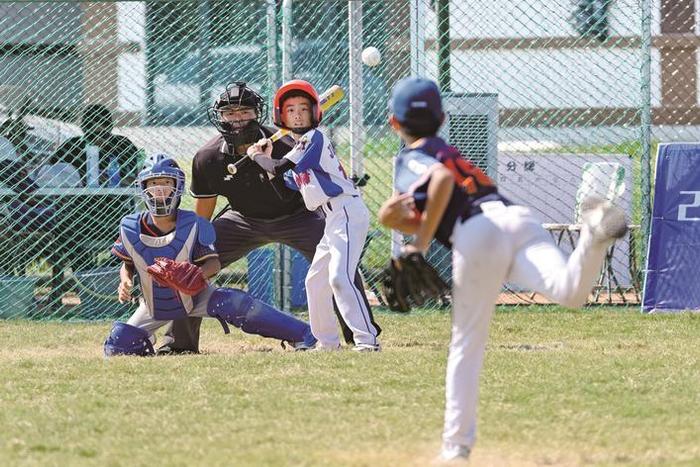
[348,0,365,180]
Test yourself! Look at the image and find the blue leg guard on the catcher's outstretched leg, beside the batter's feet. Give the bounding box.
[207,288,316,346]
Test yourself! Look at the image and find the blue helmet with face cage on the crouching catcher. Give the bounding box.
[138,154,185,216]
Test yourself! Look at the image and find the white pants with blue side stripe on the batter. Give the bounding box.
[306,195,377,348]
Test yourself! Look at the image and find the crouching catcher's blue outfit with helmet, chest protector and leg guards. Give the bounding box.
[104,155,316,355]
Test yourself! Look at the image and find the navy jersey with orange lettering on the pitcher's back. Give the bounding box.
[394,137,511,248]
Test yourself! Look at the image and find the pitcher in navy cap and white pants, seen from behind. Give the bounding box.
[379,78,627,461]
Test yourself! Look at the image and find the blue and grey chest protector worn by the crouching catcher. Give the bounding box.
[120,210,214,320]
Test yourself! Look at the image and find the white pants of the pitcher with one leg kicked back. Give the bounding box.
[443,203,609,448]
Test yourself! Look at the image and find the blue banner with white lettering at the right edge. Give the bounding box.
[642,143,700,312]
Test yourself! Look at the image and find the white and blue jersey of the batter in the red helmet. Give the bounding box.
[284,129,359,211]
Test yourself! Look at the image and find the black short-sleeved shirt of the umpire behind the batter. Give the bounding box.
[190,127,306,219]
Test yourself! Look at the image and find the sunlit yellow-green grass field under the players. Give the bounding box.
[0,307,700,466]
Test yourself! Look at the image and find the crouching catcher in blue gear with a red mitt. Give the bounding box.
[104,154,316,356]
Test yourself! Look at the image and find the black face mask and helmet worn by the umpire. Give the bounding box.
[207,81,267,151]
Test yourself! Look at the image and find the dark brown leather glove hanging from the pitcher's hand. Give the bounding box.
[381,253,448,313]
